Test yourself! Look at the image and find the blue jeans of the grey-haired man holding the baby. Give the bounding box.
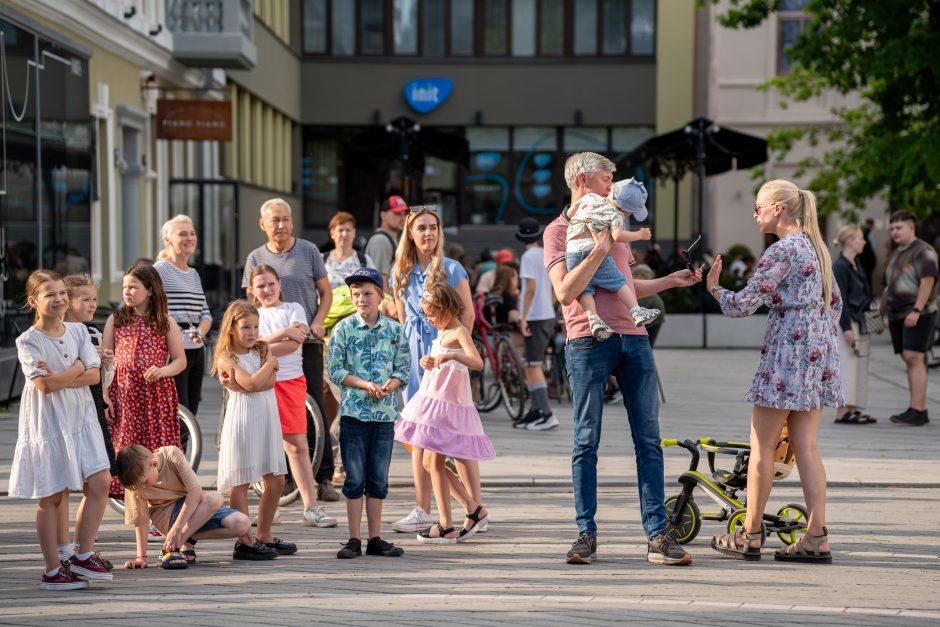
[565,334,666,539]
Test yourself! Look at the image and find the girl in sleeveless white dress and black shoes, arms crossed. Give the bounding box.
[212,300,297,560]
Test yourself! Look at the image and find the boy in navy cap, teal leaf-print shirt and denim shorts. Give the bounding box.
[328,268,411,559]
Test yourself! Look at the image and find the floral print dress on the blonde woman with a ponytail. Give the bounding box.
[719,233,843,411]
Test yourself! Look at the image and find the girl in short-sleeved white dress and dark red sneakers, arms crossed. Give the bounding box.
[9,270,111,590]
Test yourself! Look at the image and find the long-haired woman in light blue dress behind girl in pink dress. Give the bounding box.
[389,205,480,533]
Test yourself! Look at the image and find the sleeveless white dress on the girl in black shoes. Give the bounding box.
[218,351,287,492]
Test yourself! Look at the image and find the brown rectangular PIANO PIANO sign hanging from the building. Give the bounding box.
[157,100,232,142]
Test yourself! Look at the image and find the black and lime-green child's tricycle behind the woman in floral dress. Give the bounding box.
[662,427,809,544]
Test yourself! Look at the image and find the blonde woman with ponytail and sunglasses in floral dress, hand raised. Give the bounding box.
[706,180,843,563]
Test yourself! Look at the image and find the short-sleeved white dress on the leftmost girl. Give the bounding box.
[9,322,110,499]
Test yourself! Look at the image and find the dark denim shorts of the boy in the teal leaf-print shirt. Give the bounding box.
[339,416,395,499]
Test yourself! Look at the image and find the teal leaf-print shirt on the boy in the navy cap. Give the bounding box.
[327,312,411,422]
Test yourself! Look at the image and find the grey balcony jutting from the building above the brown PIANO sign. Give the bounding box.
[166,0,258,70]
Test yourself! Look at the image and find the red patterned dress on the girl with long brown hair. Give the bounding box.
[108,315,180,498]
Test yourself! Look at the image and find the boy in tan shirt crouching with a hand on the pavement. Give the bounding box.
[117,445,251,569]
